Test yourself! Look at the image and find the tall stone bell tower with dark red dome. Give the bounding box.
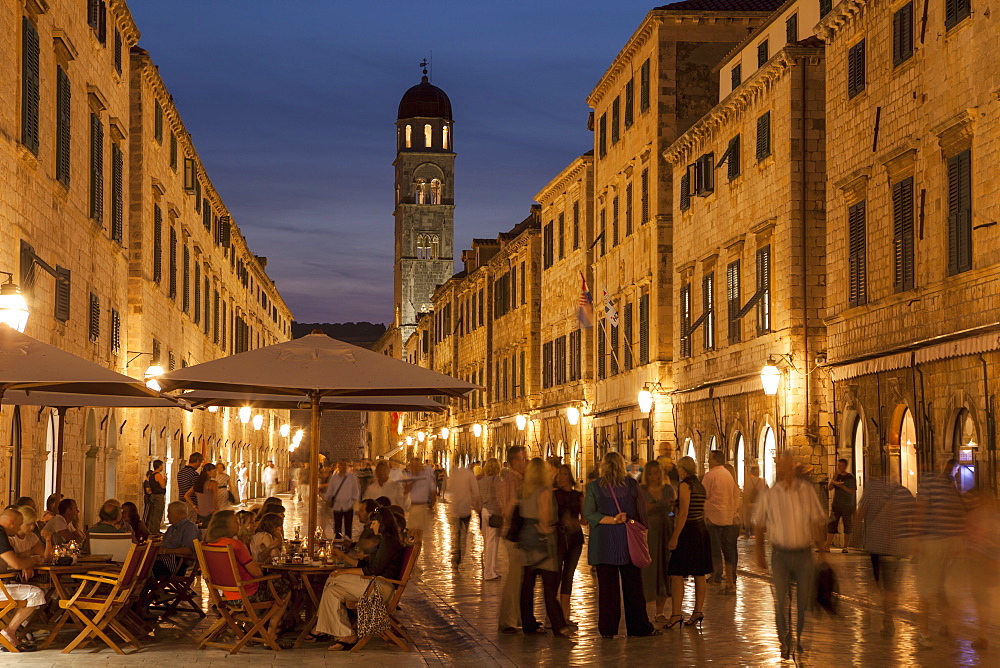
[393,61,455,344]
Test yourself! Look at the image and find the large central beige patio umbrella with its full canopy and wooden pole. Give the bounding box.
[157,331,480,553]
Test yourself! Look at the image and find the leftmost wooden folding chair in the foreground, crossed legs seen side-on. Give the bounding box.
[53,541,154,654]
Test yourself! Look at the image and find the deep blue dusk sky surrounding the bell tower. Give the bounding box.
[129,0,662,322]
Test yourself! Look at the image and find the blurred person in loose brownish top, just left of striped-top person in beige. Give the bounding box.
[857,478,916,637]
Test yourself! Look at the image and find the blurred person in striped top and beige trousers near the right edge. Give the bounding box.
[916,459,965,648]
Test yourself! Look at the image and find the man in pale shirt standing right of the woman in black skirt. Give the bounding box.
[701,450,740,594]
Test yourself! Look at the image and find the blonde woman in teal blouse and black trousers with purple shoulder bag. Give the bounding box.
[583,452,660,639]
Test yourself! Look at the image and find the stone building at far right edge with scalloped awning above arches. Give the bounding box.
[818,0,1000,493]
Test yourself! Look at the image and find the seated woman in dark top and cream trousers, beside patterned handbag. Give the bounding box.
[316,508,405,652]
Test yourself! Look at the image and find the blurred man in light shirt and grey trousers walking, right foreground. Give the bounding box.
[754,452,826,659]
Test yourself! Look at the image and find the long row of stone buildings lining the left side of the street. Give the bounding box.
[0,0,291,522]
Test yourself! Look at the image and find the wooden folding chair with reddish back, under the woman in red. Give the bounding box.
[194,540,288,654]
